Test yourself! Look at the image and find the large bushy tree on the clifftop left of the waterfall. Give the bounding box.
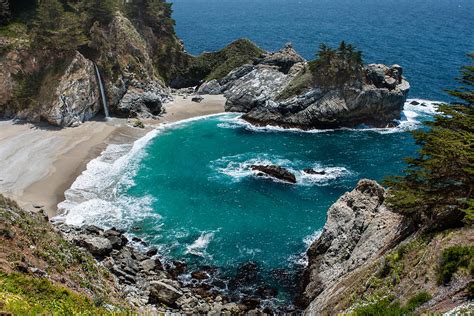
[33,0,87,52]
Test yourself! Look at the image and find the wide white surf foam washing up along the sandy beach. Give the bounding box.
[53,114,228,227]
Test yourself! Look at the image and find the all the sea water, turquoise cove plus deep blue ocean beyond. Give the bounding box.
[59,0,474,304]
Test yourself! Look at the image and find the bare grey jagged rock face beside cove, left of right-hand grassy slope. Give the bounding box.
[298,180,411,314]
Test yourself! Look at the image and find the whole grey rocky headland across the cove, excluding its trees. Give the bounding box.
[206,45,410,129]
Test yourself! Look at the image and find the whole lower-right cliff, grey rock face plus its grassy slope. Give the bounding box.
[296,180,474,315]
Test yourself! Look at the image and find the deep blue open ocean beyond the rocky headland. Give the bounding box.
[172,0,474,101]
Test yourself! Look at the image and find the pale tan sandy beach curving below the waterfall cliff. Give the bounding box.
[0,96,225,216]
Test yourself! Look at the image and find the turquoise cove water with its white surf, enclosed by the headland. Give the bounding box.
[59,104,434,301]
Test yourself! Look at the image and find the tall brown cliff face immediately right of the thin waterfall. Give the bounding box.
[96,12,172,118]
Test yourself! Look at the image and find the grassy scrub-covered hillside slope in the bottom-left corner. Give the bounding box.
[0,195,130,315]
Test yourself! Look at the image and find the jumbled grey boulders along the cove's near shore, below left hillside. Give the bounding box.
[55,223,297,315]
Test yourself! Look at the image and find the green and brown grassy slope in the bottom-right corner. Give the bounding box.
[316,227,474,316]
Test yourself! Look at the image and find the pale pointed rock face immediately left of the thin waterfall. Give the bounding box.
[41,52,102,127]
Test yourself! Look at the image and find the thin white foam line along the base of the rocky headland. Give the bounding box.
[217,99,440,134]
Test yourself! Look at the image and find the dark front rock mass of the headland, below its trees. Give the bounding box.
[243,65,410,129]
